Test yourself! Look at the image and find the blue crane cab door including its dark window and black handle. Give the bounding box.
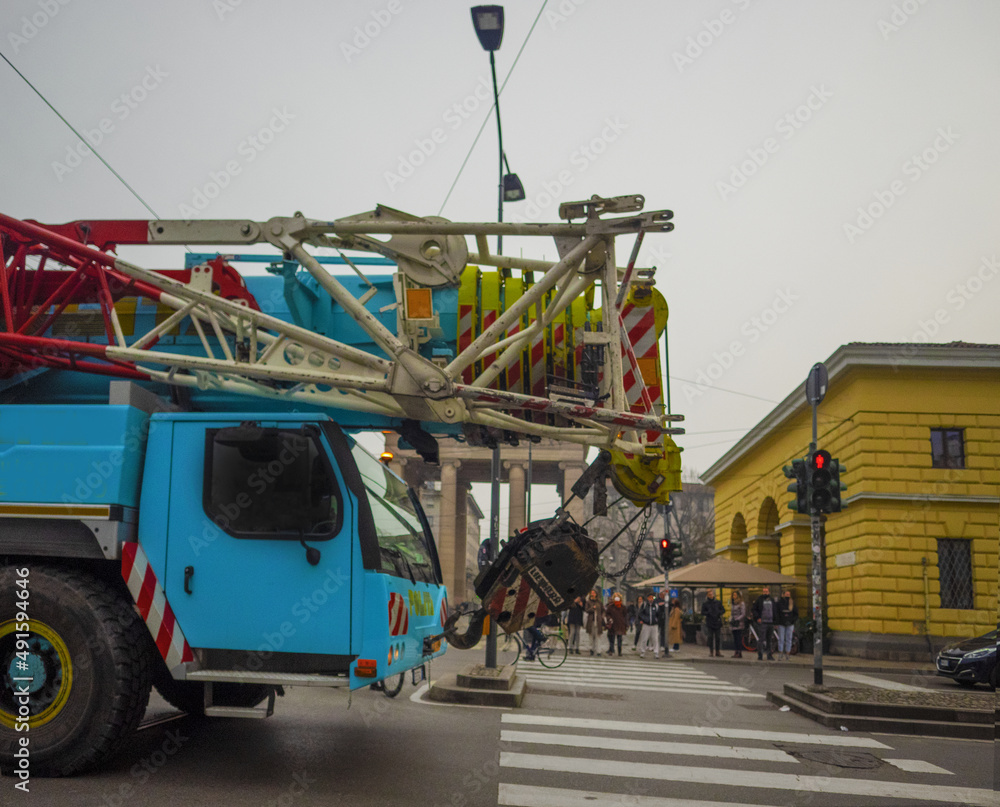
[165,420,356,654]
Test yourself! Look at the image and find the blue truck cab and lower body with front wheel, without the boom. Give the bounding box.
[0,381,445,775]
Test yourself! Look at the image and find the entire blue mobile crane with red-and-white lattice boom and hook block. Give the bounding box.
[0,195,683,776]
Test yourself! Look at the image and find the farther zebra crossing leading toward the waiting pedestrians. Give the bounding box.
[517,656,765,698]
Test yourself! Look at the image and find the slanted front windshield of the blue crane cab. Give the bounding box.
[351,441,437,583]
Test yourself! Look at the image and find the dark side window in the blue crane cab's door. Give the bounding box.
[203,424,344,541]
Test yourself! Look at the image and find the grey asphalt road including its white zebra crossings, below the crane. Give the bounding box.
[0,650,1000,807]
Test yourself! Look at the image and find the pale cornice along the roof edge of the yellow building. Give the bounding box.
[700,342,1000,484]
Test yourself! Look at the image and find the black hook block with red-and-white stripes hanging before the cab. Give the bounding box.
[475,516,597,633]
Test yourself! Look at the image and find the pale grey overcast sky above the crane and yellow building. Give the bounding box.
[0,0,1000,524]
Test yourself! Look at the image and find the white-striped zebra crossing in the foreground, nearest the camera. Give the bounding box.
[497,712,997,807]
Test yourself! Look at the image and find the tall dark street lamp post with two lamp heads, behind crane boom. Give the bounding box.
[472,6,524,668]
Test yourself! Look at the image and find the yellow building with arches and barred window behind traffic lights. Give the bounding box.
[702,342,1000,659]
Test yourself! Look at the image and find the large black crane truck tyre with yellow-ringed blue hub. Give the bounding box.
[0,563,151,776]
